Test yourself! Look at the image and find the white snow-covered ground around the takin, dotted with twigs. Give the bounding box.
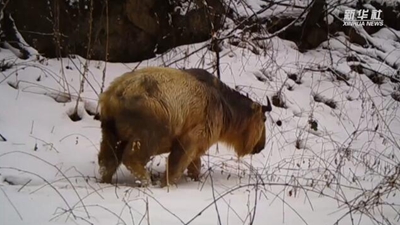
[0,25,400,225]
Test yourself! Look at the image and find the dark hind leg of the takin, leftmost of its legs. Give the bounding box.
[98,139,127,183]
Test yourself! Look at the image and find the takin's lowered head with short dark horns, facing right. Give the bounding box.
[232,98,272,157]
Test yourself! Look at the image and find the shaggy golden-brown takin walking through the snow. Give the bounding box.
[98,67,271,186]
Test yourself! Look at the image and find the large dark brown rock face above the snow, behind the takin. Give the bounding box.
[5,0,224,62]
